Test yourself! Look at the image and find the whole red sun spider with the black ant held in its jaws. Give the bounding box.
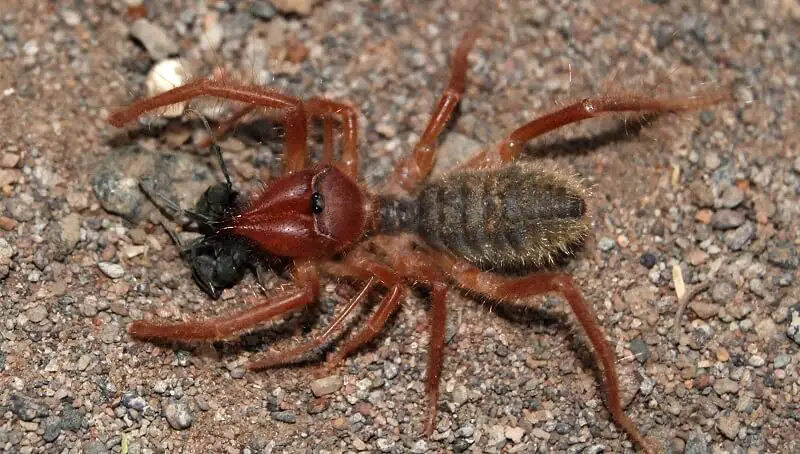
[109,31,725,450]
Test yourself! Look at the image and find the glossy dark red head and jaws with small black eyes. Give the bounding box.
[228,166,367,257]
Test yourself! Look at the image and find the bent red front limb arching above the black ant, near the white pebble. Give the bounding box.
[108,78,308,173]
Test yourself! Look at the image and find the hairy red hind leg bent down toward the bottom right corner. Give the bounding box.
[441,257,655,452]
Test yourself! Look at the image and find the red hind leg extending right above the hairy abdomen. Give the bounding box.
[466,92,729,168]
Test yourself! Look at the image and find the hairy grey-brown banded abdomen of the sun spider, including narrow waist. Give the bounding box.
[381,164,588,268]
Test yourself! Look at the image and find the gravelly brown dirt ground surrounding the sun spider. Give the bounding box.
[0,0,800,454]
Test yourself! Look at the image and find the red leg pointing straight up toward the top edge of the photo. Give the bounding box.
[389,29,478,191]
